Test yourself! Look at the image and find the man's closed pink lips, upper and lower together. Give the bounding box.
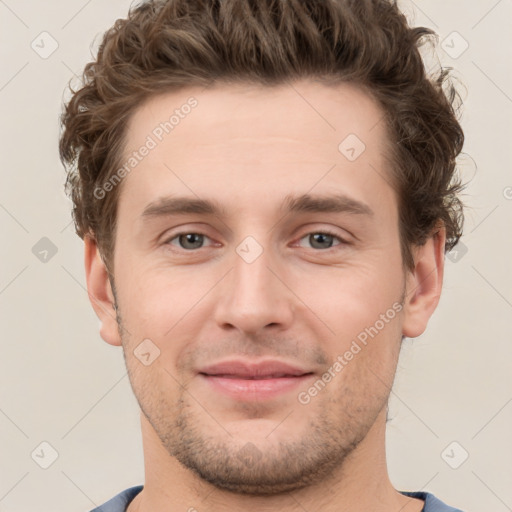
[198,360,314,401]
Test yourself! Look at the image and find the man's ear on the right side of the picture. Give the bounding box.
[402,226,446,338]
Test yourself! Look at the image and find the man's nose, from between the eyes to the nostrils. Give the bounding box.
[215,242,296,335]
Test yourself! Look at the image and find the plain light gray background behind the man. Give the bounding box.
[0,0,512,512]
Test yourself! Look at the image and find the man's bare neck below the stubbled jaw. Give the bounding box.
[128,409,424,512]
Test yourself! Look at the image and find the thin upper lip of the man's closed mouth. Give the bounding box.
[198,359,313,379]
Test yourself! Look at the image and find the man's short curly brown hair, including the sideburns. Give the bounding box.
[59,0,464,271]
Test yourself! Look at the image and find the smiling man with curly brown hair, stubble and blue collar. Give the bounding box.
[60,0,463,512]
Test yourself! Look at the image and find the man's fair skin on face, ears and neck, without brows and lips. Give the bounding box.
[85,81,445,512]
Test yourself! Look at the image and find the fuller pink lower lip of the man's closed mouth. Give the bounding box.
[201,374,313,400]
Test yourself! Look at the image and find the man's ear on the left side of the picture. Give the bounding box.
[84,235,121,346]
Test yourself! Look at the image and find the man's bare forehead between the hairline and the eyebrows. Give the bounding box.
[119,81,392,221]
